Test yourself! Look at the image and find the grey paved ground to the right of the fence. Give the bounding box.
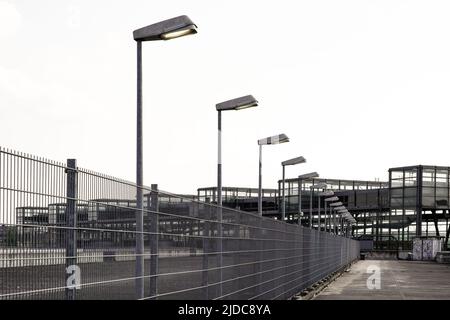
[315,260,450,300]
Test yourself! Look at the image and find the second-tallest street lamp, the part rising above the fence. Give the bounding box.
[216,95,258,206]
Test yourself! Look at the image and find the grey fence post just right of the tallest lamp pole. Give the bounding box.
[149,184,159,298]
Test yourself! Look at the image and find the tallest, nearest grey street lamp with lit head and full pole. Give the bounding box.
[133,16,197,299]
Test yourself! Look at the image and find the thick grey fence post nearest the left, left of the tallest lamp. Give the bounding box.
[65,159,79,300]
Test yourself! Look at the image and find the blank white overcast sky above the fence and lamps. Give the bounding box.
[0,0,450,193]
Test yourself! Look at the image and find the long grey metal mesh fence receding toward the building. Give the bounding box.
[0,148,359,300]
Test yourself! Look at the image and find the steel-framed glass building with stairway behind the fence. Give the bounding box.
[198,165,450,250]
